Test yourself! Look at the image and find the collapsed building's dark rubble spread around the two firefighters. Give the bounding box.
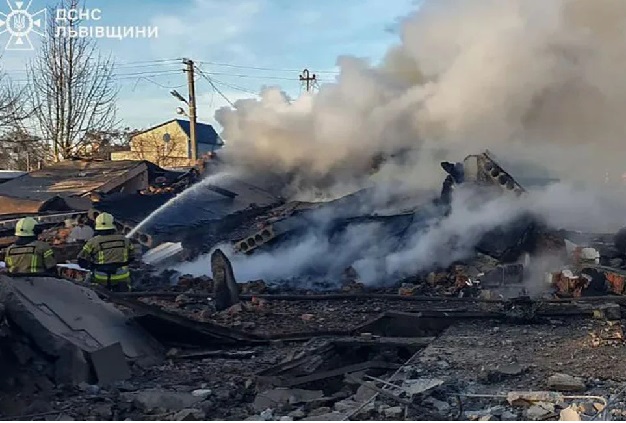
[0,152,626,421]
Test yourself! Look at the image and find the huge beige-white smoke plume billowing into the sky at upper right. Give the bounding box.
[217,0,626,193]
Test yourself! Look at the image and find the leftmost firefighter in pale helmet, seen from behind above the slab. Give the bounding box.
[4,217,57,276]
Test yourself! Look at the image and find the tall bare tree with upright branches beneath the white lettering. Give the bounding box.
[28,0,118,160]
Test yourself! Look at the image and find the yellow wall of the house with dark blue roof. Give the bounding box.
[111,122,192,167]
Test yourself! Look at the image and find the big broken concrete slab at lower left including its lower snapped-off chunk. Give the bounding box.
[0,276,159,384]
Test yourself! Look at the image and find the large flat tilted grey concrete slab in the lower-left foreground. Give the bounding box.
[0,276,159,359]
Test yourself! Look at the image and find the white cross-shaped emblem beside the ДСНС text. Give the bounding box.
[0,0,46,50]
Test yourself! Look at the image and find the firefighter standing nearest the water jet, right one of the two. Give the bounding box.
[78,213,134,291]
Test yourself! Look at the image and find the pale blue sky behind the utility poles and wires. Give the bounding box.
[0,0,416,129]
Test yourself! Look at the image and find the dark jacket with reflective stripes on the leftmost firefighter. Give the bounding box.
[4,241,57,275]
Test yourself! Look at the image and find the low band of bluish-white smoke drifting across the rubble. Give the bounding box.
[178,184,623,285]
